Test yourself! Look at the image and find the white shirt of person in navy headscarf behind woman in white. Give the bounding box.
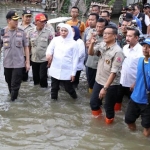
[76,39,85,70]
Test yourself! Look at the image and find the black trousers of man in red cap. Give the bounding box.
[32,61,48,88]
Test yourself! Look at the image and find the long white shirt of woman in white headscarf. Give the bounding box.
[46,36,79,80]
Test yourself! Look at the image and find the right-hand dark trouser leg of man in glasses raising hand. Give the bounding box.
[104,85,118,119]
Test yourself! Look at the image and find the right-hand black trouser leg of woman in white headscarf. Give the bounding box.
[63,80,77,99]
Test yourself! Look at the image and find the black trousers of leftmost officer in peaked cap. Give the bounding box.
[4,68,23,101]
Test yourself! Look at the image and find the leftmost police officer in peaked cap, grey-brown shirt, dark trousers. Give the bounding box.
[2,11,30,101]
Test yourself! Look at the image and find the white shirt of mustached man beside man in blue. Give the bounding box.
[120,43,143,87]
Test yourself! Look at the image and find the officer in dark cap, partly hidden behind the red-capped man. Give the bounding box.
[18,10,35,81]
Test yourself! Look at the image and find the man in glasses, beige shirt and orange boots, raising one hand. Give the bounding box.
[88,26,124,124]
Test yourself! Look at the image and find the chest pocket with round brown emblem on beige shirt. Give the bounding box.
[104,55,112,71]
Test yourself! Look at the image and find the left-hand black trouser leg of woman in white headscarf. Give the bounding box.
[51,77,60,99]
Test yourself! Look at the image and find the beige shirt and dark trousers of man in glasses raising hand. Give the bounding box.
[90,42,124,119]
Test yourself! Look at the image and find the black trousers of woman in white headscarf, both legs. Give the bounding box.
[51,77,77,99]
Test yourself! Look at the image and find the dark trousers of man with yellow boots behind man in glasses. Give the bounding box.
[86,67,97,89]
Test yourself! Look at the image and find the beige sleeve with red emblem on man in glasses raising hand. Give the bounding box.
[111,51,125,73]
